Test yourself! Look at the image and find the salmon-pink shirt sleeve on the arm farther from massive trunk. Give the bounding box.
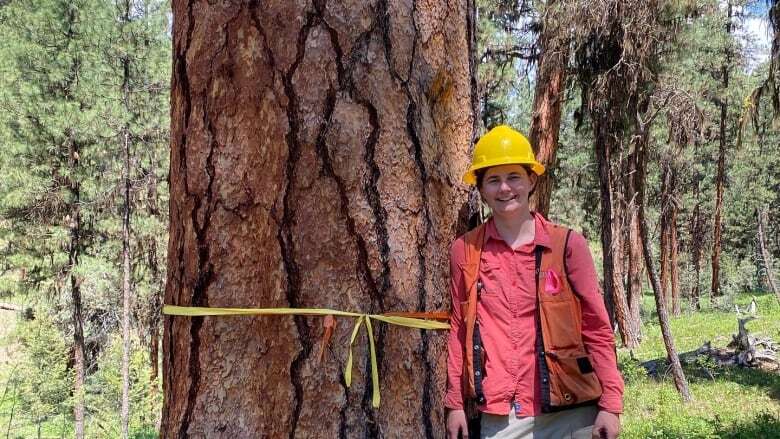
[566,231,623,414]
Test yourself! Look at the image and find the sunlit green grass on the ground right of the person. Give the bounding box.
[618,293,780,438]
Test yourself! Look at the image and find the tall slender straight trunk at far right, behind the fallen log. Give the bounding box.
[710,1,732,299]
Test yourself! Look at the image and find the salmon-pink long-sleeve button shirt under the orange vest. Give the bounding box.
[444,214,623,416]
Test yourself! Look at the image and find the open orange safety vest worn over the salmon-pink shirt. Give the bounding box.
[461,224,601,413]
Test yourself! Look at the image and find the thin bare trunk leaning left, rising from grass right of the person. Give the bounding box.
[639,167,692,402]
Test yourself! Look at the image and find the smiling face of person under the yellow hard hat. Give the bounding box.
[479,165,536,216]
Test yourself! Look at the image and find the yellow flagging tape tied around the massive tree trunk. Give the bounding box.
[163,305,450,408]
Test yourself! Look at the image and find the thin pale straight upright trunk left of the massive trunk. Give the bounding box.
[120,0,132,439]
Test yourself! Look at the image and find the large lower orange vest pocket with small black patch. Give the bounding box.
[546,352,601,407]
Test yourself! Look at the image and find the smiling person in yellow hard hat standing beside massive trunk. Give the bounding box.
[445,126,623,439]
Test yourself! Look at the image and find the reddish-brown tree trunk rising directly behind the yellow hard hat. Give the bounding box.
[529,1,569,216]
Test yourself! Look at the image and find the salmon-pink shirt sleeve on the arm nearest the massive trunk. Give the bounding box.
[444,238,467,409]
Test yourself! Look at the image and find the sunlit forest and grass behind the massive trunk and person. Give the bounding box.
[0,0,780,438]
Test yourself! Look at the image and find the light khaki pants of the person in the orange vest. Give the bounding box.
[481,406,598,439]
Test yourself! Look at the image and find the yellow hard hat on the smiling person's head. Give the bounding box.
[463,125,544,185]
